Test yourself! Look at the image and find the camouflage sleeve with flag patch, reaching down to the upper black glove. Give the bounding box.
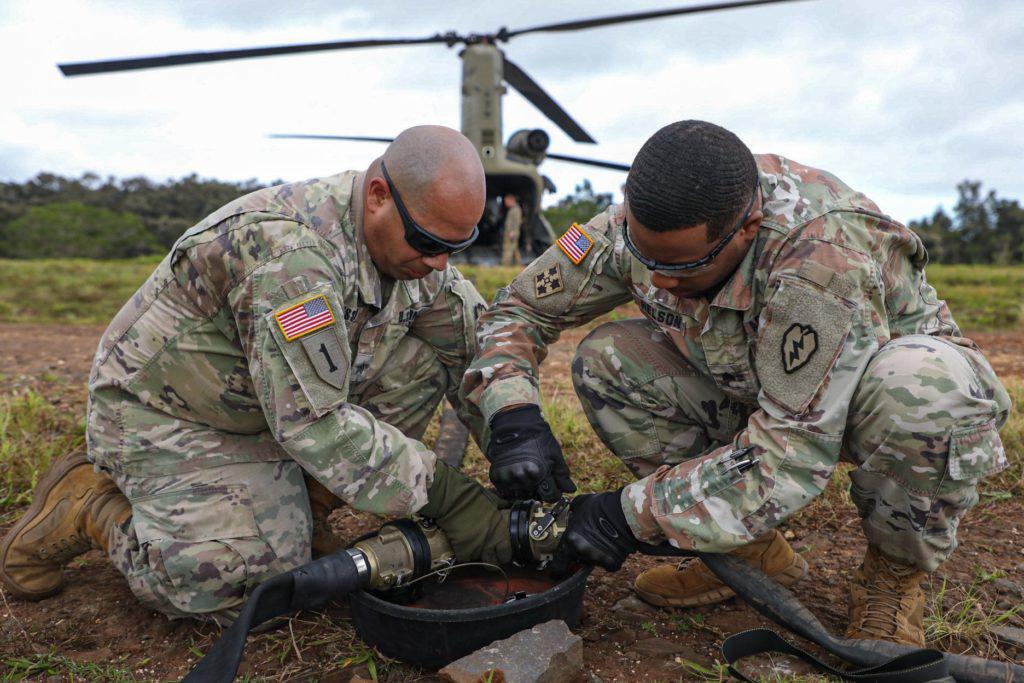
[461,207,630,422]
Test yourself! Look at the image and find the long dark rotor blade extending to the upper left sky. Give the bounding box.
[57,34,456,77]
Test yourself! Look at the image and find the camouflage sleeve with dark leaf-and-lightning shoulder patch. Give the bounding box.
[623,232,883,552]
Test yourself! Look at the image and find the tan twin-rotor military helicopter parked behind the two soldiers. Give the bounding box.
[58,0,791,260]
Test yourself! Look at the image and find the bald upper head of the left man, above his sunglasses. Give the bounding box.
[374,126,486,217]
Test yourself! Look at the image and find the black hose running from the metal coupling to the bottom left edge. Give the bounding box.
[183,550,364,683]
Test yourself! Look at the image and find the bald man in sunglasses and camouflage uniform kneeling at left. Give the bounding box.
[0,126,510,623]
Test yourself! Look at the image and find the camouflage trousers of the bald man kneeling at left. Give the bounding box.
[102,336,449,624]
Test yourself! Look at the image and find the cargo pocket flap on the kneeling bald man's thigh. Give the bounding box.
[131,484,259,543]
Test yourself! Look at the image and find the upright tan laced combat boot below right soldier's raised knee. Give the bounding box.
[846,546,926,647]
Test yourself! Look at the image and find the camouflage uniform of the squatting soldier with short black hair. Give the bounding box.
[462,156,1010,570]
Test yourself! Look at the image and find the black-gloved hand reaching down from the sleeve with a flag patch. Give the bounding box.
[486,405,575,503]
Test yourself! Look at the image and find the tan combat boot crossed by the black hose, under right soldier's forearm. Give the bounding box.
[633,529,807,607]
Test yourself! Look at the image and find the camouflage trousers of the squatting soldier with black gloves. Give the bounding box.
[572,319,1010,571]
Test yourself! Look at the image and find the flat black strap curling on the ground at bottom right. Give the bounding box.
[722,629,952,683]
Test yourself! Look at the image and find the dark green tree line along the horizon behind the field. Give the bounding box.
[0,173,1024,264]
